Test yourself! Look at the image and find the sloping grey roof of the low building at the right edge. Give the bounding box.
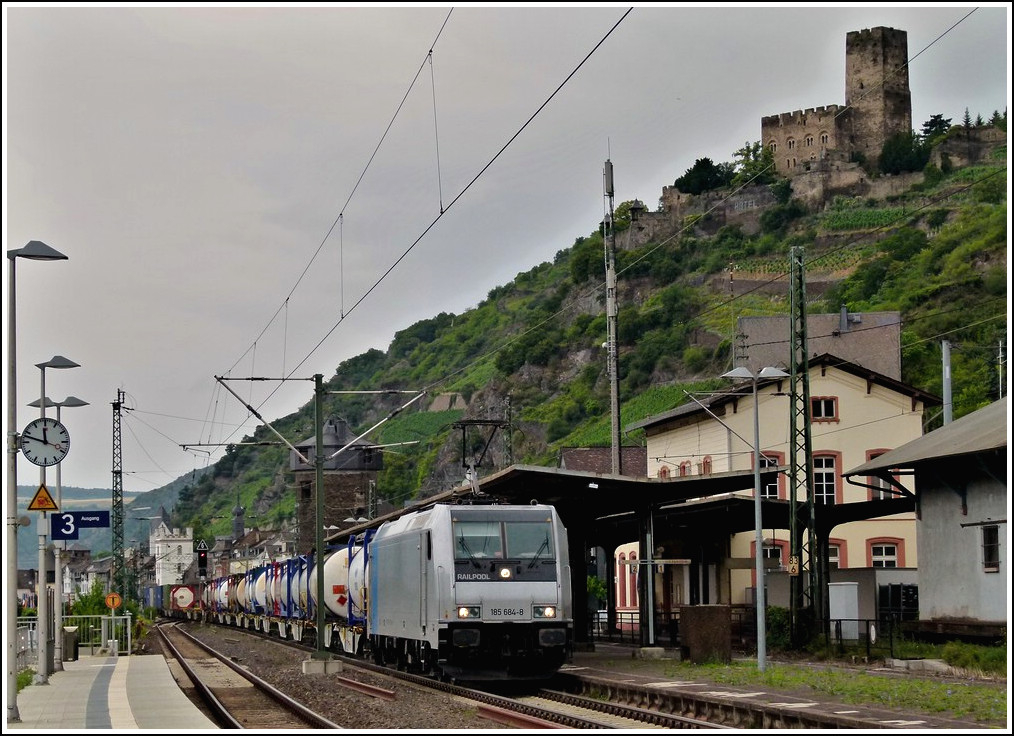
[842,396,1008,477]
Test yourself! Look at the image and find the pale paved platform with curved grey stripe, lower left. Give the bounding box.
[4,655,219,733]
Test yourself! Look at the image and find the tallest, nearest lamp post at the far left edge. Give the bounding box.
[7,240,67,723]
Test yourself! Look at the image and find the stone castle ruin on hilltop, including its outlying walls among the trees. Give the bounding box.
[617,26,1005,249]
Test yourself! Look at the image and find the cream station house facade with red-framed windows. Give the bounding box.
[618,354,939,605]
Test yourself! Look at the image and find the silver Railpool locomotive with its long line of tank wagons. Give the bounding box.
[147,504,574,681]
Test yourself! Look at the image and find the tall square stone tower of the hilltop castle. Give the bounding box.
[845,26,912,163]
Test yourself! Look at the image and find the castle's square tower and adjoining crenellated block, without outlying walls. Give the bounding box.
[761,26,912,177]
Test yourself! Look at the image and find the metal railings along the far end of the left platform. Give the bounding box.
[16,612,134,671]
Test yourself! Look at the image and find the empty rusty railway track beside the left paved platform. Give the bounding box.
[158,625,340,730]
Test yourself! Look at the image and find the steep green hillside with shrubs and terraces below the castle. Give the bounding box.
[128,128,1008,538]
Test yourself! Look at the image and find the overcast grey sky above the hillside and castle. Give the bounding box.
[3,3,1011,500]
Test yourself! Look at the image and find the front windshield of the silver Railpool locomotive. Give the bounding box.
[453,520,555,561]
